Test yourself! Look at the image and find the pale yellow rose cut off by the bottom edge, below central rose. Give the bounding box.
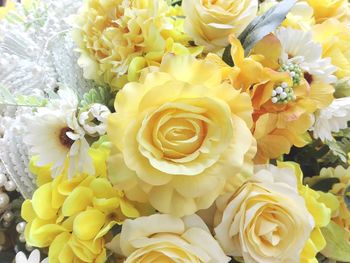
[108,214,230,263]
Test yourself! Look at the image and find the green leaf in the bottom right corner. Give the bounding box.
[321,221,350,262]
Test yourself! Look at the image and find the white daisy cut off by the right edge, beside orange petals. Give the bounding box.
[311,97,350,141]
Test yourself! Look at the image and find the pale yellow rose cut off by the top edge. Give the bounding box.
[182,0,258,51]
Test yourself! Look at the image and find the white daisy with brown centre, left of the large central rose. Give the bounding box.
[24,90,94,178]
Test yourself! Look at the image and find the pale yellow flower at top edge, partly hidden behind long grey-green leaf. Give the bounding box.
[258,0,315,31]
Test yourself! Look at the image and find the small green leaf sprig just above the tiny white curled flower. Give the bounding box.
[80,87,115,110]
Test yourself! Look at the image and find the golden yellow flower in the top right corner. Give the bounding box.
[301,0,350,23]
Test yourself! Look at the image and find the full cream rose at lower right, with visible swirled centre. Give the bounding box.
[214,166,314,263]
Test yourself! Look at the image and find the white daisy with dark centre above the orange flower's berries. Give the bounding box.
[276,27,337,84]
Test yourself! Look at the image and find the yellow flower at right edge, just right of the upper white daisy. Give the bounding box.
[313,19,350,79]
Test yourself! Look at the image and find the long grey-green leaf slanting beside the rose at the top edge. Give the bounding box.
[222,0,297,66]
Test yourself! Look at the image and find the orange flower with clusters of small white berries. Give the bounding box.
[216,34,334,163]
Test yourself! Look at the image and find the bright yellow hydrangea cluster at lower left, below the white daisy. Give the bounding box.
[21,150,148,263]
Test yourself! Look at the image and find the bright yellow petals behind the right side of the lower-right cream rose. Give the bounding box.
[278,162,337,263]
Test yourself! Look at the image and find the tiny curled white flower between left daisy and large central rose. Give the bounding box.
[79,103,111,136]
